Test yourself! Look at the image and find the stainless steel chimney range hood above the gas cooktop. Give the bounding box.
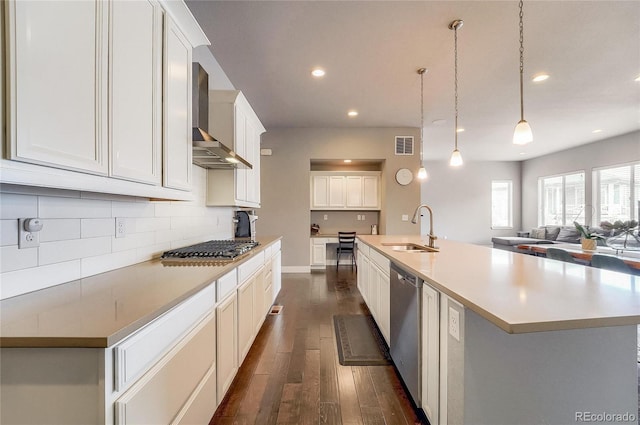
[192,62,253,169]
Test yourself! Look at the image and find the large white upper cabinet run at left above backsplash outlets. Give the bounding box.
[0,0,208,199]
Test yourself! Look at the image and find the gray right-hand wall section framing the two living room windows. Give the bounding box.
[522,131,640,230]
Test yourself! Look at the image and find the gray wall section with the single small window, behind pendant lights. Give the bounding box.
[421,161,521,245]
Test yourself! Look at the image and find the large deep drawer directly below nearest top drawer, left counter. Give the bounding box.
[115,313,216,425]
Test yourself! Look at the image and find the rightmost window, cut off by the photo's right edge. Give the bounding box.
[593,163,640,223]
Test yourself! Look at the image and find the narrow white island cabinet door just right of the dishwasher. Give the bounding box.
[422,284,440,423]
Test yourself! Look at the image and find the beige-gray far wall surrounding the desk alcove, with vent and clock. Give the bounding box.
[257,128,420,269]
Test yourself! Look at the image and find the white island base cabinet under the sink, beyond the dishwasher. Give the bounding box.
[356,243,391,344]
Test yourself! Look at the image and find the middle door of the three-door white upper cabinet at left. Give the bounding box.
[109,0,162,184]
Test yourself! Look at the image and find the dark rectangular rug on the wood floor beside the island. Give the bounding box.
[333,314,391,366]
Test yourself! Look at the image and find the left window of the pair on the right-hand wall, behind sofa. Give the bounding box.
[538,172,585,226]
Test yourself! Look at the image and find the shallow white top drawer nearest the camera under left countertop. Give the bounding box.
[114,285,215,391]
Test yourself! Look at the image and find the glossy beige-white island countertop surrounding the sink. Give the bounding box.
[358,235,640,333]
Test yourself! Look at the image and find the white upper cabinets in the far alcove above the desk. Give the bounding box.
[310,171,380,210]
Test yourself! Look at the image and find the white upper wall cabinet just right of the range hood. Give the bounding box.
[207,90,265,208]
